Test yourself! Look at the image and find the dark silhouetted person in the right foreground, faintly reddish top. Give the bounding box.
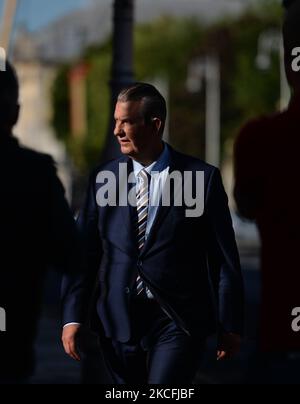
[234,0,300,353]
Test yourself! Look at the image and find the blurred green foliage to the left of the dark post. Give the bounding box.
[52,46,110,173]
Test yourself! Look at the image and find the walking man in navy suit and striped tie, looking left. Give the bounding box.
[62,83,243,384]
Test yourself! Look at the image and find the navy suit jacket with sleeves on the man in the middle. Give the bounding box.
[62,147,243,342]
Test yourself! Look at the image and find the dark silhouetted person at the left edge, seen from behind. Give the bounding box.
[0,62,78,383]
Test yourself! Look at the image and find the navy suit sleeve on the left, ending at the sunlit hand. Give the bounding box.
[62,170,102,324]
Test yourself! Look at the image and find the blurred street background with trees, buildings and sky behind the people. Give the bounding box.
[0,0,296,383]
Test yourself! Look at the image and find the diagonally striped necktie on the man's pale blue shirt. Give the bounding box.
[136,169,153,299]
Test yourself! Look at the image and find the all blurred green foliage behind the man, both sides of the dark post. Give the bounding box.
[53,0,282,171]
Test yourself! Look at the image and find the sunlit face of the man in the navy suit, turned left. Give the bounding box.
[114,101,160,160]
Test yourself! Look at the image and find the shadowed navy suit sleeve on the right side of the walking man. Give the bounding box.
[206,169,244,335]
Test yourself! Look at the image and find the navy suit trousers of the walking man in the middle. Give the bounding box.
[103,298,205,384]
